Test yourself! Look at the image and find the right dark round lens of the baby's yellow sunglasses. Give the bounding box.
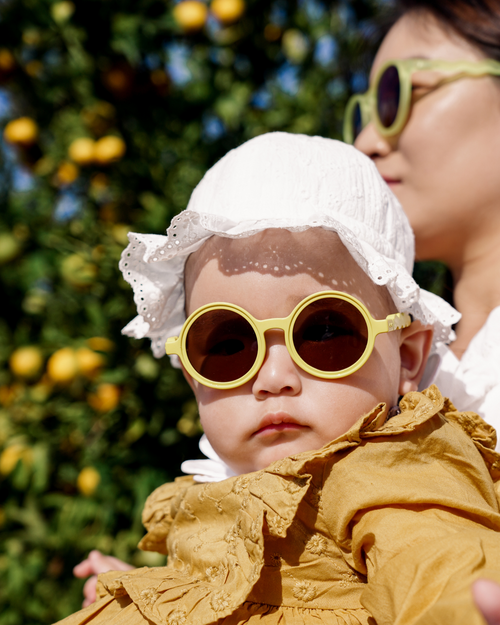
[293,298,368,371]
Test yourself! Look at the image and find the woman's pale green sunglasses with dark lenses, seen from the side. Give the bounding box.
[344,59,500,143]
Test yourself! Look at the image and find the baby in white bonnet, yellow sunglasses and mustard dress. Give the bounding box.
[58,133,500,625]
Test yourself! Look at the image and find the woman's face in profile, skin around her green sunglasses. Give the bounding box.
[355,12,500,269]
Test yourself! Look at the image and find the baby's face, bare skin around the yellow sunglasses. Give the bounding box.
[186,228,400,473]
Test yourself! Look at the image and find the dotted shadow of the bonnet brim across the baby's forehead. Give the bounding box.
[186,228,395,314]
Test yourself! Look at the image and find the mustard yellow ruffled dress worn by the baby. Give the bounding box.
[55,387,500,625]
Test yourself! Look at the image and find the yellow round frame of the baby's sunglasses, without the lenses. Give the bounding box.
[165,291,412,389]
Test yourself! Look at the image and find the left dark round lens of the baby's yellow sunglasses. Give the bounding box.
[186,309,257,382]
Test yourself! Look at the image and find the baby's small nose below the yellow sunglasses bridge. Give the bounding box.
[252,330,302,399]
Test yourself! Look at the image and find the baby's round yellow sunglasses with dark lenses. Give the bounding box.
[165,291,411,389]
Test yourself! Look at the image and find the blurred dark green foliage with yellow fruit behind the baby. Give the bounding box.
[0,0,450,625]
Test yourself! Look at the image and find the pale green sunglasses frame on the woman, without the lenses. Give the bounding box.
[344,59,500,144]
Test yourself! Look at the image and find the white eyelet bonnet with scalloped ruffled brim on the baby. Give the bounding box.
[120,132,460,358]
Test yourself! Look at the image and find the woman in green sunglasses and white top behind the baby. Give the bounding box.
[346,0,500,436]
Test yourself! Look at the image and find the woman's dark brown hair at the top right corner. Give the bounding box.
[390,0,500,61]
